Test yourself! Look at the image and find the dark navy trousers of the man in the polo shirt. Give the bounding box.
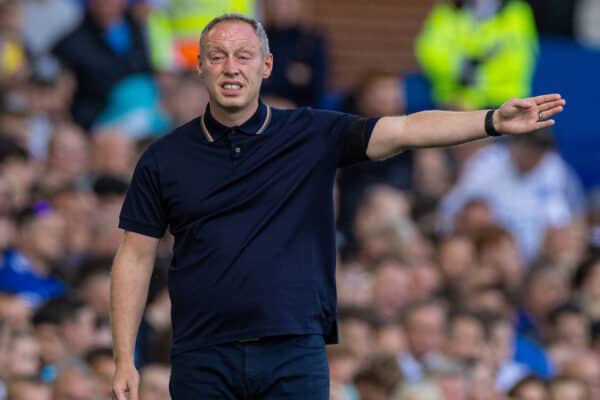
[170,335,329,400]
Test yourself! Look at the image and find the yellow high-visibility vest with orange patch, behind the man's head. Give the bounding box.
[148,0,256,69]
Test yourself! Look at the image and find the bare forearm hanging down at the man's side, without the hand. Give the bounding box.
[111,239,153,364]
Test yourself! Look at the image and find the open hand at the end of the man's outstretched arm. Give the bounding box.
[494,94,566,135]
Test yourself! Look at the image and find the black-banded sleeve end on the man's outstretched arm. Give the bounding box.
[337,115,379,167]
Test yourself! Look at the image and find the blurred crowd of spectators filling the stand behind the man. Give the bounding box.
[0,0,600,400]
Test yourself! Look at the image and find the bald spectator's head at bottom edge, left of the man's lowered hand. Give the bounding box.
[52,367,97,400]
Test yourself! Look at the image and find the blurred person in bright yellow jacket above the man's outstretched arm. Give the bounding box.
[416,0,538,109]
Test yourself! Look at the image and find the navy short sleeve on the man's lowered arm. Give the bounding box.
[119,148,167,238]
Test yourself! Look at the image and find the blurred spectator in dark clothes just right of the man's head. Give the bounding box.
[262,0,328,107]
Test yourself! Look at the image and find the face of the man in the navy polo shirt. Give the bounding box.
[198,21,273,112]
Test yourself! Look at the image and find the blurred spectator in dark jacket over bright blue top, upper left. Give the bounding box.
[52,0,151,129]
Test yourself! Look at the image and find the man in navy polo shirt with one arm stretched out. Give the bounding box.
[112,15,564,400]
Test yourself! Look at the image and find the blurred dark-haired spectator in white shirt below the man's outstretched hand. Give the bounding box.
[441,130,584,262]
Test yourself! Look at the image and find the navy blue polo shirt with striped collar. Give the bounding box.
[119,102,377,354]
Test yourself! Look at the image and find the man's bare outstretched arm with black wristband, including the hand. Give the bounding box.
[367,94,565,160]
